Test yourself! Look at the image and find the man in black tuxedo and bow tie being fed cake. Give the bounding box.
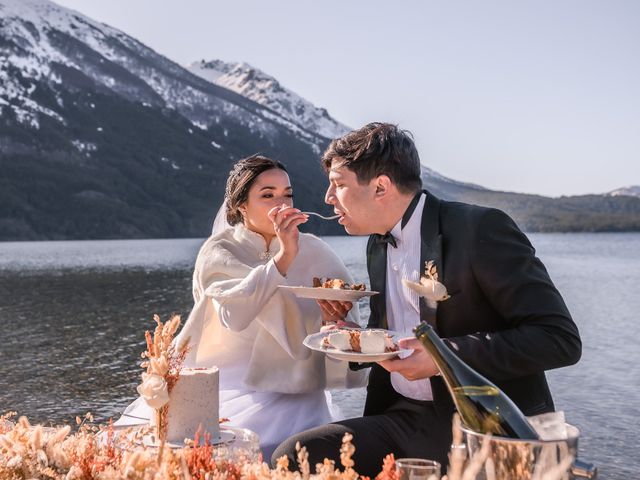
[272,123,581,478]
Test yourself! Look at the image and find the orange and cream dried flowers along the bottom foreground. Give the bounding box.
[0,414,572,480]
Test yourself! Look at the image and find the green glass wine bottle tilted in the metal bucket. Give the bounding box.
[414,322,539,440]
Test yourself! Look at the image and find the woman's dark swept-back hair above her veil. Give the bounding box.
[224,155,287,225]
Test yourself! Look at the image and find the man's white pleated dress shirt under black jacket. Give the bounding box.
[385,193,433,400]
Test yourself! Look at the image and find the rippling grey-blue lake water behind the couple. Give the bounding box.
[0,233,640,479]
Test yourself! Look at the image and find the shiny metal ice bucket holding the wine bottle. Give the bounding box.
[462,423,598,480]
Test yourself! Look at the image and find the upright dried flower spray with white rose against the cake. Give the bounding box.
[137,315,188,444]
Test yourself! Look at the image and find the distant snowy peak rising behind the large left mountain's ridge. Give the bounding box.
[188,60,350,139]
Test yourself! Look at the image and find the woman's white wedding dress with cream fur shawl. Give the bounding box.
[118,225,366,460]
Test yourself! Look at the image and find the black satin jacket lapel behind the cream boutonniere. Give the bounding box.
[420,190,444,331]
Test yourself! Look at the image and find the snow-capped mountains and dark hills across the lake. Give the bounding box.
[0,0,640,241]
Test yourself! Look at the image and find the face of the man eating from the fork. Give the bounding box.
[324,158,377,235]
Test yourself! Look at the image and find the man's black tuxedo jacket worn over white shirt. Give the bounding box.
[364,192,582,417]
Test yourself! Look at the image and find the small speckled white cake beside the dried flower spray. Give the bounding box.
[161,367,220,444]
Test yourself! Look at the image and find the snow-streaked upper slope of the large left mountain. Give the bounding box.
[0,0,328,152]
